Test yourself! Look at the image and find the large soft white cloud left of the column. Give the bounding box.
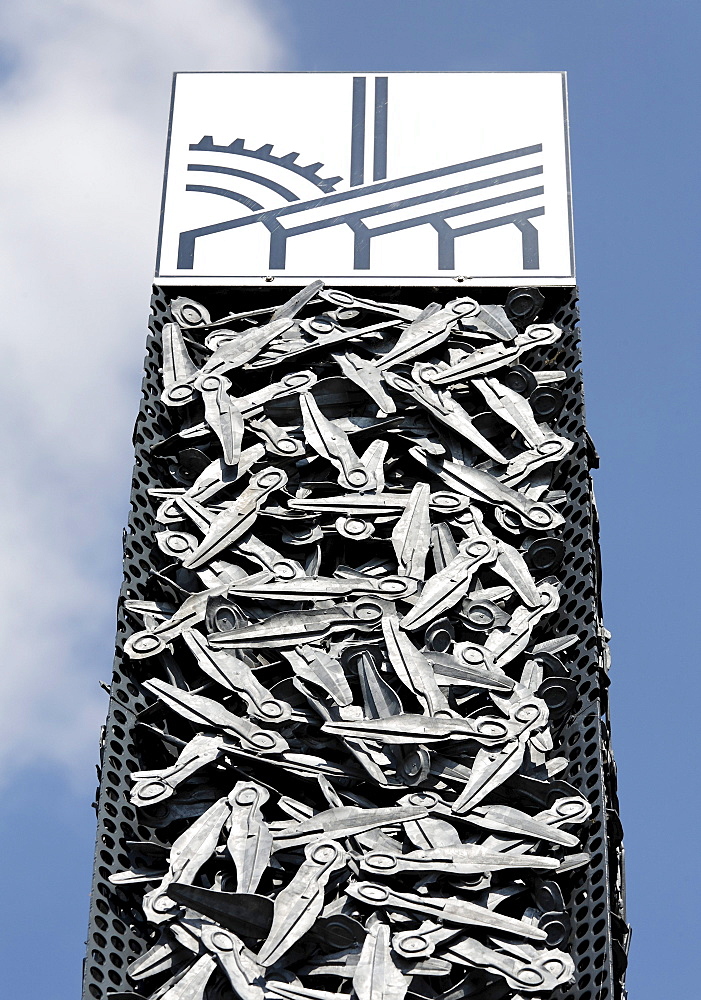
[0,0,285,782]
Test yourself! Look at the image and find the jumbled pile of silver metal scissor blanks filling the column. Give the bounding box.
[113,282,591,1000]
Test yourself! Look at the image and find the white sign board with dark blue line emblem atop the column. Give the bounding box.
[156,73,574,285]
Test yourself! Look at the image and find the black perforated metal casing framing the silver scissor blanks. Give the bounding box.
[83,287,629,1000]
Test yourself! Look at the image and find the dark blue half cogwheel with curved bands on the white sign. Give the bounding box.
[187,135,342,212]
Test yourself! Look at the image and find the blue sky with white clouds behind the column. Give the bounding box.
[0,0,701,1000]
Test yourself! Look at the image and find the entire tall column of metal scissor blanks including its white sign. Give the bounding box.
[84,73,629,1000]
